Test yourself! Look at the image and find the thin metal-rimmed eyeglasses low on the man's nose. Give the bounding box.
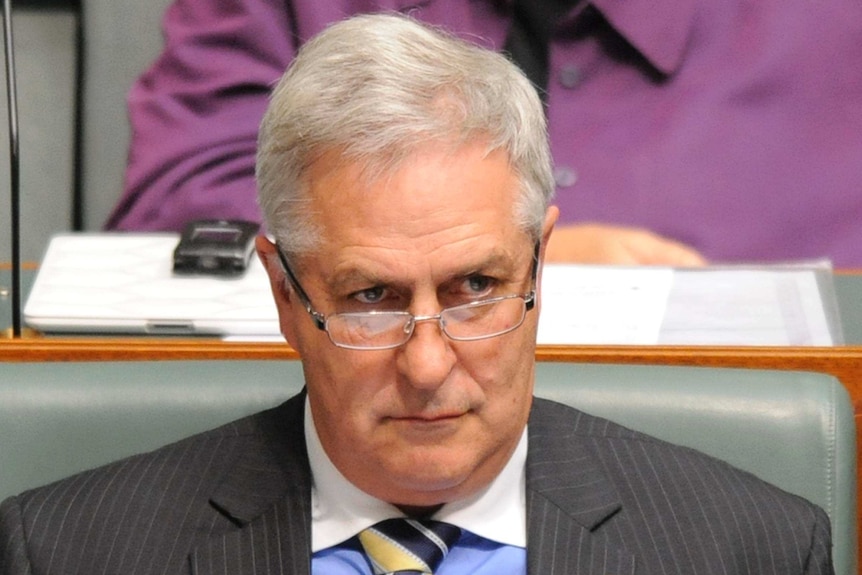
[277,243,540,350]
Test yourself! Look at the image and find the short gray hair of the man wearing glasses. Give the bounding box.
[256,14,554,254]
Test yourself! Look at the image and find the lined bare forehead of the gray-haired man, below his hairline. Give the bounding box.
[307,145,520,235]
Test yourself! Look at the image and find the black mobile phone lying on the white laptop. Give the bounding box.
[174,220,260,276]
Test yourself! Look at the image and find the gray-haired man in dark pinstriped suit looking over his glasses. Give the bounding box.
[0,16,832,575]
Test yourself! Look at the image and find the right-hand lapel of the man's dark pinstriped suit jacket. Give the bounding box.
[527,399,635,575]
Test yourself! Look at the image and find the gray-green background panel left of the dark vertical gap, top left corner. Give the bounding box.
[0,0,78,260]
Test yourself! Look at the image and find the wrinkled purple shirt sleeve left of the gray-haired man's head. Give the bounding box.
[106,0,296,230]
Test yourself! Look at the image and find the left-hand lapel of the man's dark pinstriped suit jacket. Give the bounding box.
[189,393,311,575]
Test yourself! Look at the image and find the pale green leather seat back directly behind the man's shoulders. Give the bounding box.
[0,360,857,574]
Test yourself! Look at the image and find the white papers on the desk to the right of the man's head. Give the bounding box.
[538,262,843,346]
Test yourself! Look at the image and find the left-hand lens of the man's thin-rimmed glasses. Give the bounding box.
[326,312,412,349]
